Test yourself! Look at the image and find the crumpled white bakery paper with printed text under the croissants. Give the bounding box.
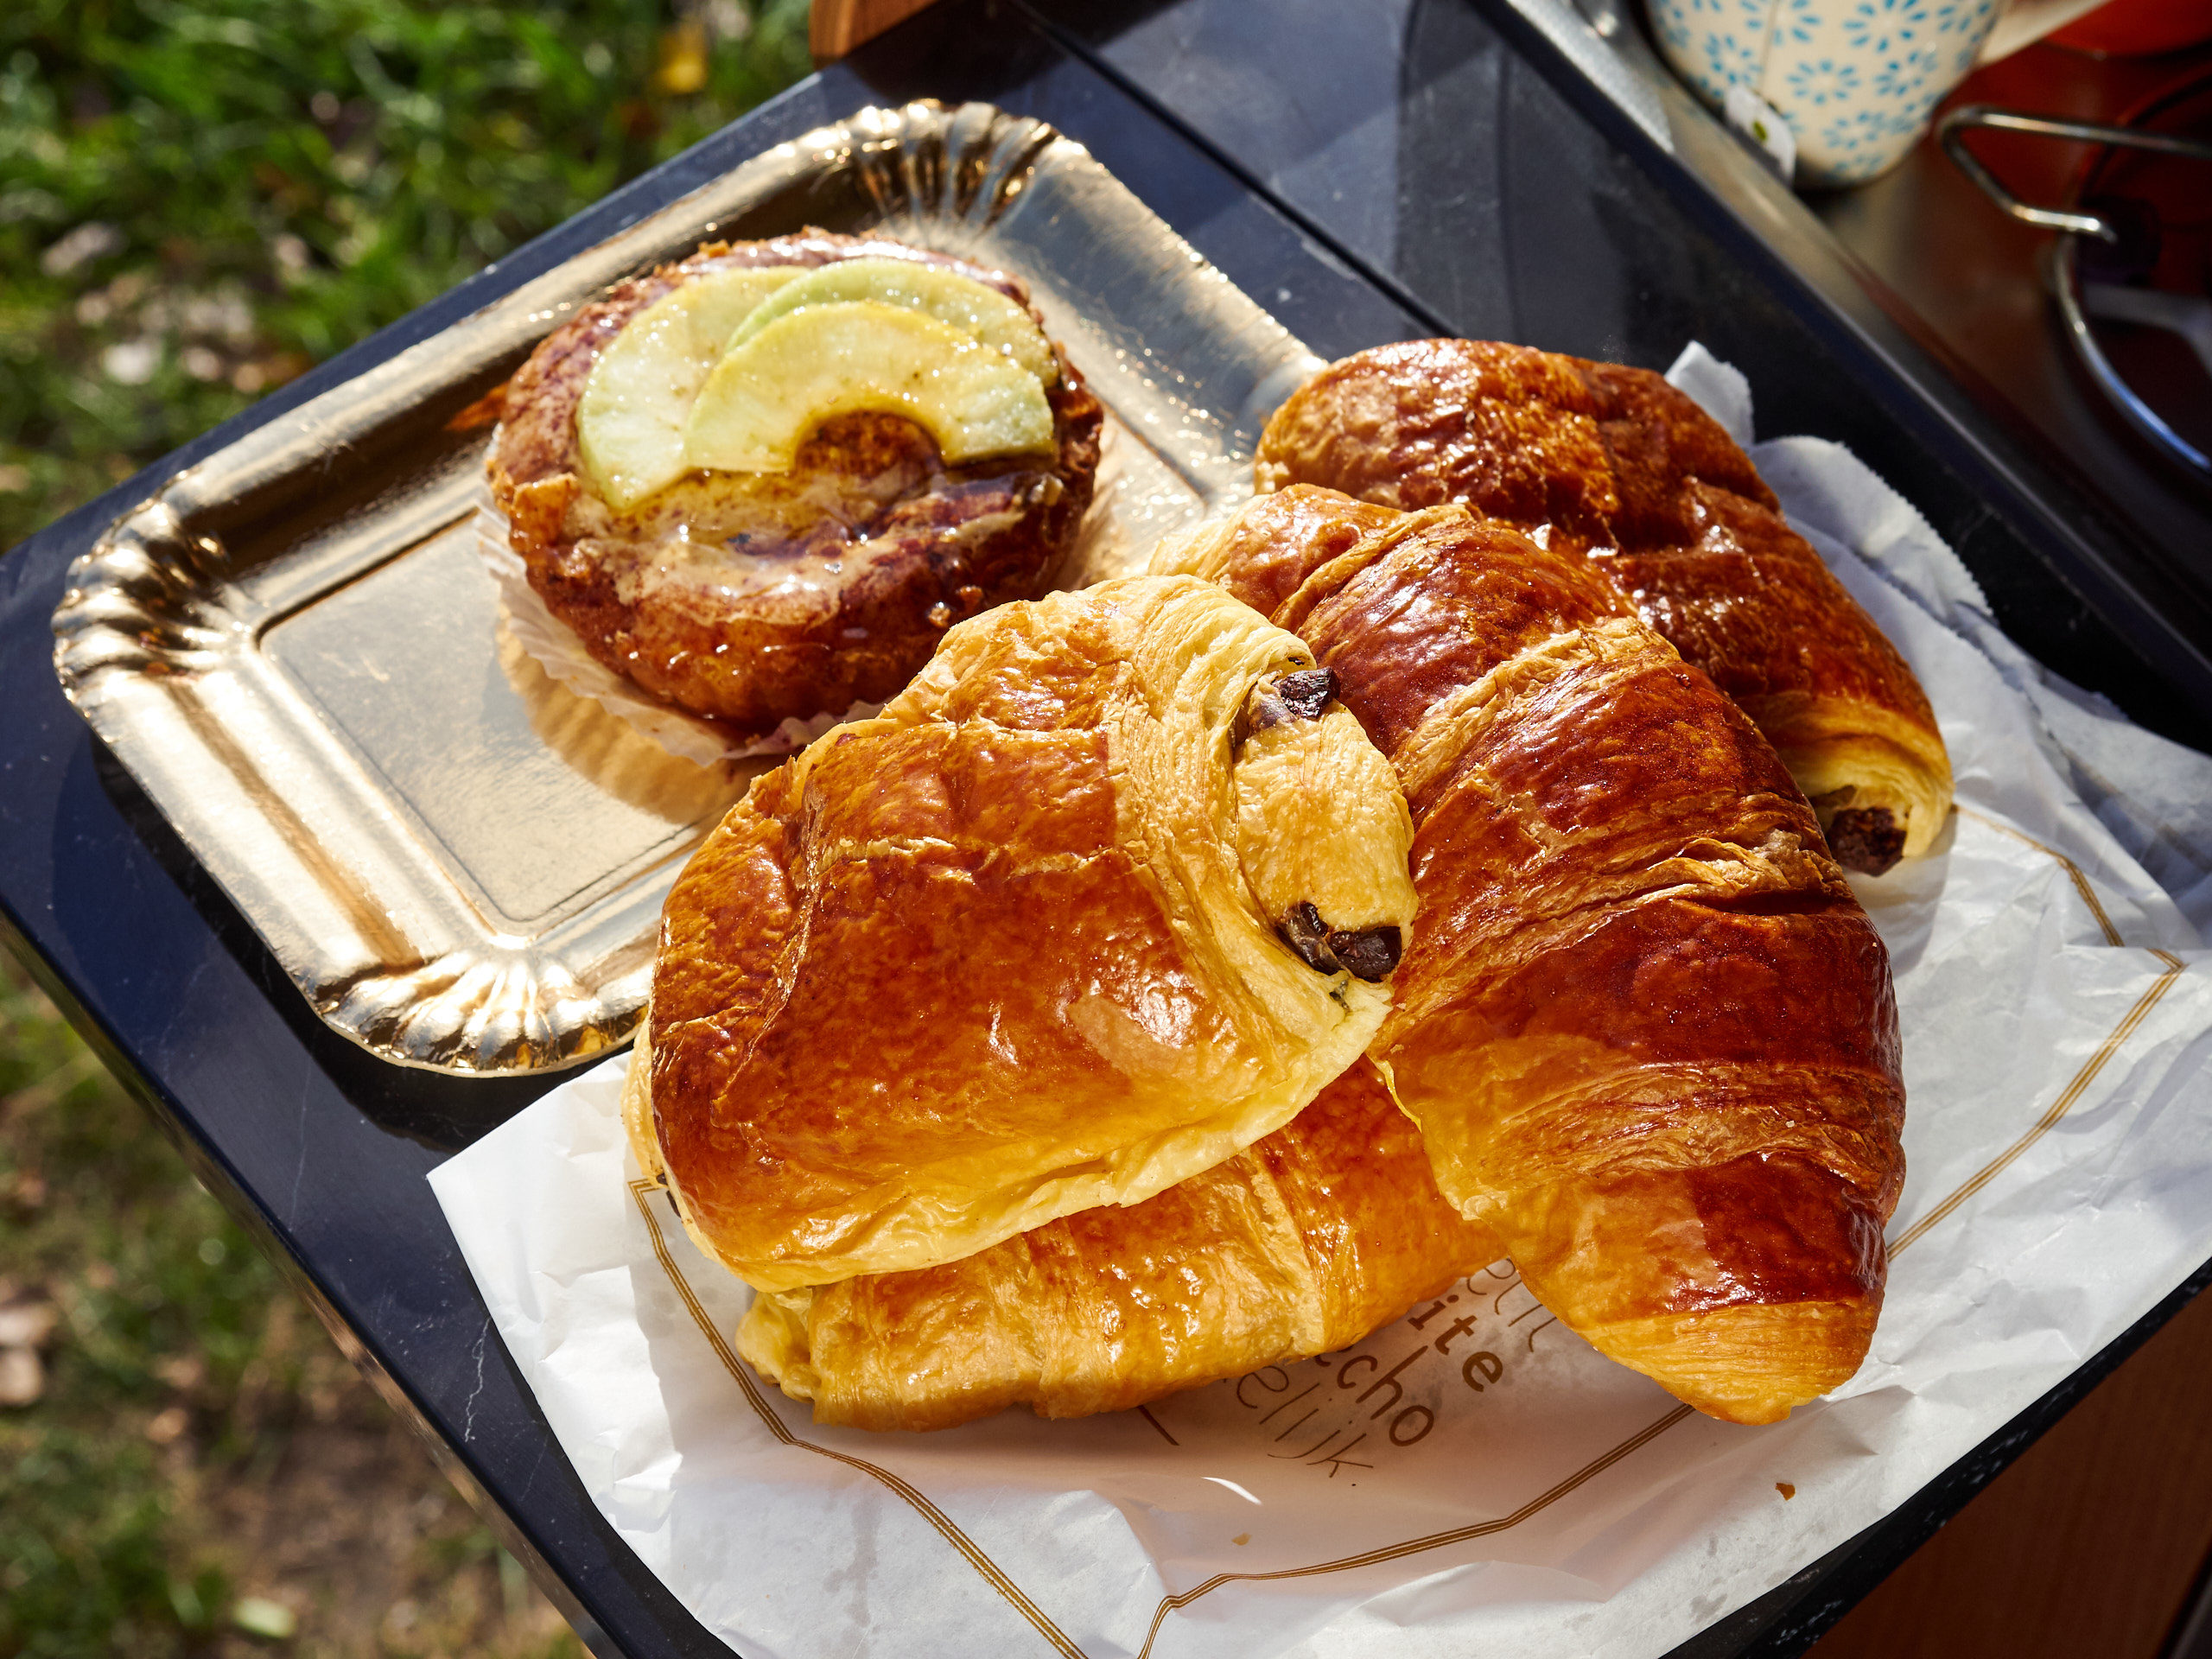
[431,347,2212,1659]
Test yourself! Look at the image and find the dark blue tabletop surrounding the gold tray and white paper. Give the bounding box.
[0,0,2212,1659]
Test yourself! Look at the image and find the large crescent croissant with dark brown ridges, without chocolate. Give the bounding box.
[1153,485,1904,1422]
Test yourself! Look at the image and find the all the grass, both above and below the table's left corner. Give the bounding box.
[0,0,807,1659]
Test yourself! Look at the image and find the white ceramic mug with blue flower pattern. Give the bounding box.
[1650,0,2002,186]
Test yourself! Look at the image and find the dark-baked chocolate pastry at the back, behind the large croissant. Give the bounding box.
[1256,340,1951,874]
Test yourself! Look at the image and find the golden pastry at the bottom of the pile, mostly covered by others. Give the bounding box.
[736,1059,1502,1429]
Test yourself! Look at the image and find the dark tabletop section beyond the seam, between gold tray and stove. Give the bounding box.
[1035,0,2212,747]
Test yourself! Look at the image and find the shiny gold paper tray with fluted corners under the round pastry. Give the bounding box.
[53,104,1319,1073]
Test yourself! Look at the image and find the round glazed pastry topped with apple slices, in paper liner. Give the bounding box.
[489,230,1103,734]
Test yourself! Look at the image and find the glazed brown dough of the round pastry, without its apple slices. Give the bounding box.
[489,230,1103,734]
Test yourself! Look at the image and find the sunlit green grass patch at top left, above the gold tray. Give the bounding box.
[0,0,807,546]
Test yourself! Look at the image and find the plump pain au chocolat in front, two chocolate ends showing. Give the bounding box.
[637,577,1414,1289]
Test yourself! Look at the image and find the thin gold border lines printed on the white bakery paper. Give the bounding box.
[631,827,2188,1659]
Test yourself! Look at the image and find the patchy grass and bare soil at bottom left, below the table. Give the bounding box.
[0,929,606,1659]
